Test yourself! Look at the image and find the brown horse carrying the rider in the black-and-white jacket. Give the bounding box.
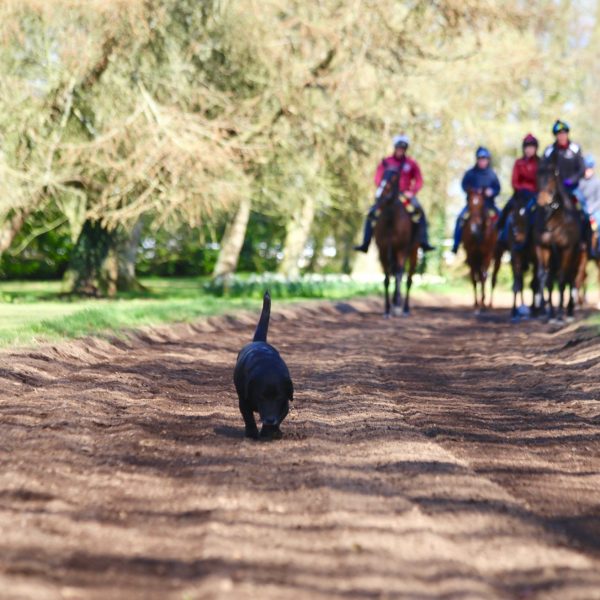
[534,161,582,320]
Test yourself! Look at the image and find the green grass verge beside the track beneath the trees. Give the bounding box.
[0,274,600,347]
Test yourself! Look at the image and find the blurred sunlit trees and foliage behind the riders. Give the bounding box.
[0,0,599,295]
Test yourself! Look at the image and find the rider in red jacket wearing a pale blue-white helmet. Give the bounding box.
[354,135,433,252]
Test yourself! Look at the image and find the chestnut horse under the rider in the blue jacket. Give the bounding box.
[462,189,498,310]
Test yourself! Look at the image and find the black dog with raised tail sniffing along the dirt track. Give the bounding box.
[233,292,294,439]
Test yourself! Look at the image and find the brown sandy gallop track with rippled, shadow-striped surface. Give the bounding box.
[0,301,600,600]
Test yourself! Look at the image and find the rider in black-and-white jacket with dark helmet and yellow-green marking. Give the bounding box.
[544,119,591,243]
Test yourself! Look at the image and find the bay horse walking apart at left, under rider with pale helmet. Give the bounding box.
[374,170,419,318]
